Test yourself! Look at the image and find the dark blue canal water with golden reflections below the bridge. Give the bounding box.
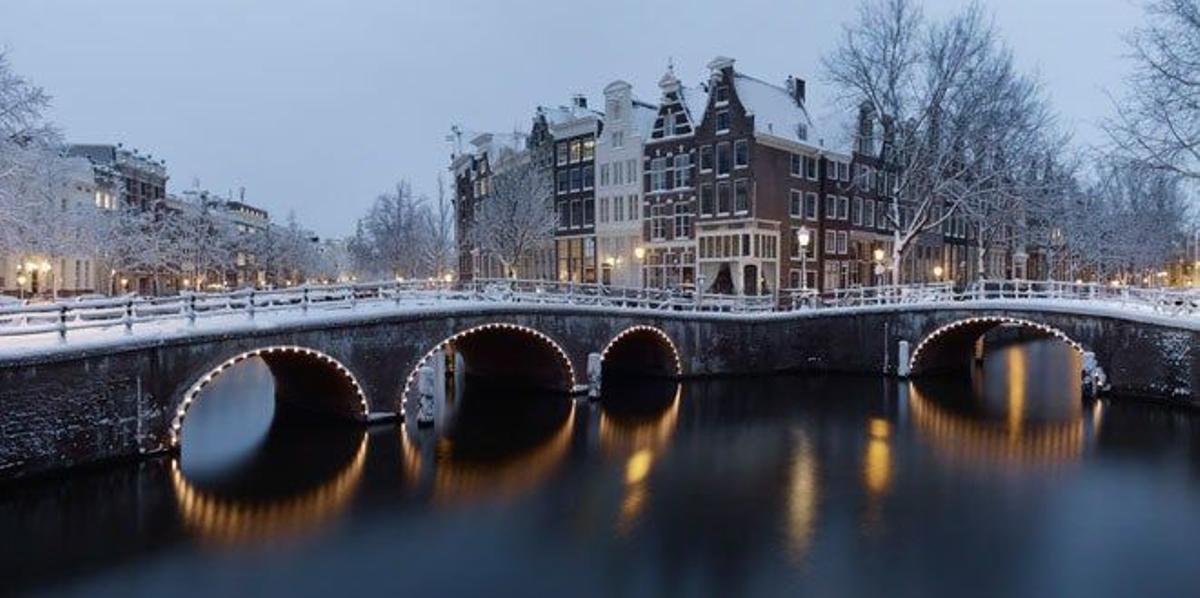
[0,341,1200,597]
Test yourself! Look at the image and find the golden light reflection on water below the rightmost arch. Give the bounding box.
[908,383,1084,468]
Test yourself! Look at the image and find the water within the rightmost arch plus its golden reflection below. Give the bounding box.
[908,340,1085,470]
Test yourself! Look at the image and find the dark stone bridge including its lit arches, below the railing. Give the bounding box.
[0,300,1200,478]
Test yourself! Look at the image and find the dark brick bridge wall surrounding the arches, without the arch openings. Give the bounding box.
[0,304,1200,478]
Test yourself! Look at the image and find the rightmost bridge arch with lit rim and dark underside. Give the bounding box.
[908,316,1087,376]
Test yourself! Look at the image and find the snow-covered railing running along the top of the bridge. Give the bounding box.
[0,280,1200,340]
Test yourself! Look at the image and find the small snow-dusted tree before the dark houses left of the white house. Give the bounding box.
[472,161,557,276]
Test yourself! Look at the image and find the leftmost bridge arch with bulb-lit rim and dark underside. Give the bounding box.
[170,345,370,448]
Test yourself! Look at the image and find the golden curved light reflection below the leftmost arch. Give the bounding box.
[170,433,367,544]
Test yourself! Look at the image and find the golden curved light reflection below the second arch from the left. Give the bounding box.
[433,401,575,506]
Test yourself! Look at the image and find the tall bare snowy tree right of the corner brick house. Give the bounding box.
[824,0,1049,282]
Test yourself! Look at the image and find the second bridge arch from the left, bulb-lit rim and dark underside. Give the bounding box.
[400,322,576,414]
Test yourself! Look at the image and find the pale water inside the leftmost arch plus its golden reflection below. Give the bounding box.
[169,358,367,544]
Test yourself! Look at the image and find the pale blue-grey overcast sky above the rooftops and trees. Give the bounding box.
[0,0,1142,237]
